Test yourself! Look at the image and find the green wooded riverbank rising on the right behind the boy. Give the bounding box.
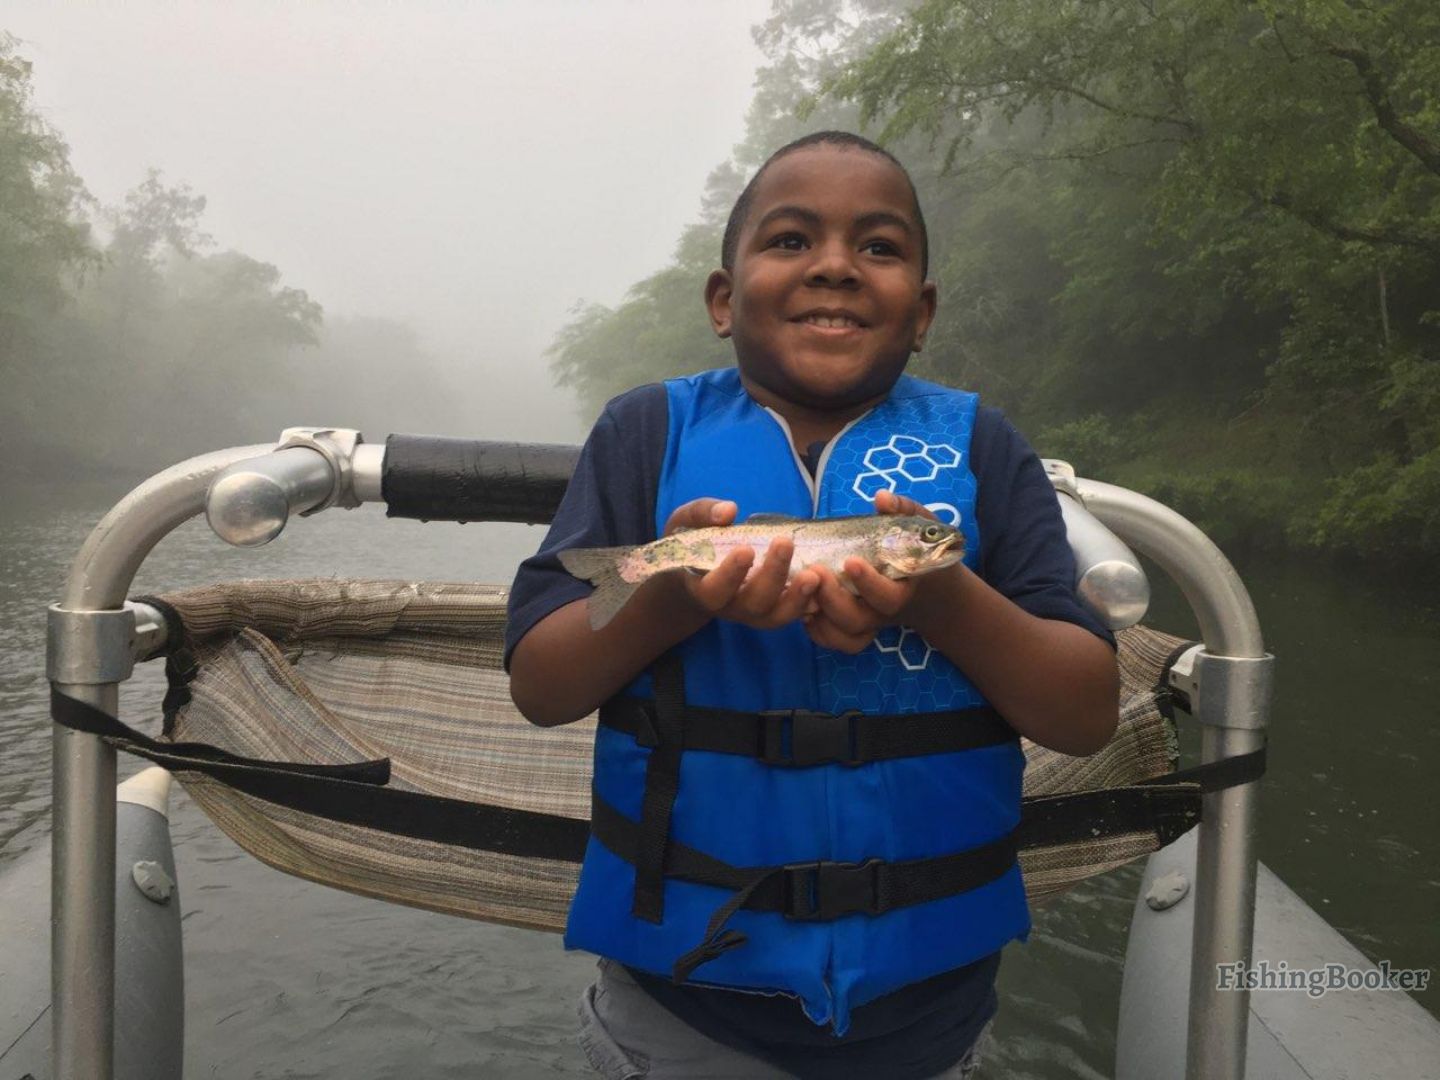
[552,0,1440,567]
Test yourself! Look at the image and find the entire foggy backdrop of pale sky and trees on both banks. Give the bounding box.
[0,0,1440,585]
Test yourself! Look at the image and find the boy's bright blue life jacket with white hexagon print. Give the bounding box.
[564,369,1030,1034]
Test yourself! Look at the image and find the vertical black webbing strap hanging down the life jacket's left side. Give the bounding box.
[631,652,685,923]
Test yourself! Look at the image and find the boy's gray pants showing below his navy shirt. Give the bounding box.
[580,960,989,1080]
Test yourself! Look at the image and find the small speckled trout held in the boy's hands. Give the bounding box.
[559,514,965,629]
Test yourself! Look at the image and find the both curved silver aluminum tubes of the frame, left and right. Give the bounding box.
[52,444,1264,1080]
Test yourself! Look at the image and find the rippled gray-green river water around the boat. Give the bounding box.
[0,480,1440,1080]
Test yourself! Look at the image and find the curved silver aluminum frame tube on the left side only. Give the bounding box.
[50,444,272,1080]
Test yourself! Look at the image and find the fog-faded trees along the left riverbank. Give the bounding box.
[0,32,464,480]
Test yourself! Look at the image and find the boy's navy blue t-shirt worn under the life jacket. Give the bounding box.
[505,383,1115,1080]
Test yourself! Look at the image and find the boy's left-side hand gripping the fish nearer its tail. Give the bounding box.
[665,498,819,629]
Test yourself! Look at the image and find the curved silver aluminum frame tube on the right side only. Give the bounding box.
[1076,480,1266,1080]
